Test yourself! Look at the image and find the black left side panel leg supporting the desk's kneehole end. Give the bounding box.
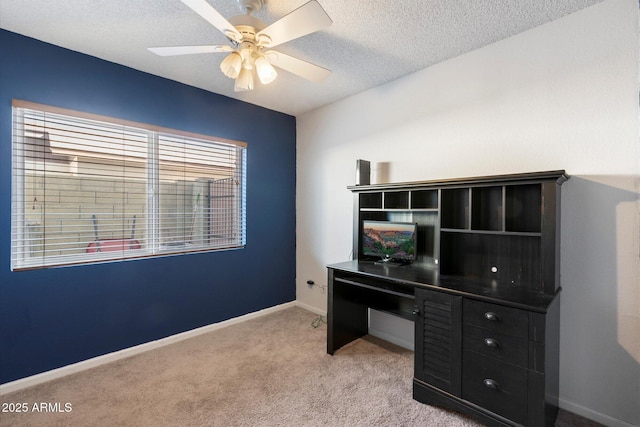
[327,270,369,354]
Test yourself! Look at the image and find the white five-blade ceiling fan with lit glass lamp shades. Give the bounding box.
[148,0,332,91]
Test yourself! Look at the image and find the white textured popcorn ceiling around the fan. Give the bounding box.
[0,0,601,115]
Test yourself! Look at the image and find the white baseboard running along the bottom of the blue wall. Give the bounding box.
[0,301,300,396]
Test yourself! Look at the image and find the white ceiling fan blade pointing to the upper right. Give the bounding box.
[258,0,333,47]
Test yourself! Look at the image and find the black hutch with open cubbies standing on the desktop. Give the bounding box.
[349,171,568,294]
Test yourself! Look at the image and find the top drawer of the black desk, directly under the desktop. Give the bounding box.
[462,298,529,338]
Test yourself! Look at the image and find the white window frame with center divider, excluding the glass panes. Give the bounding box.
[11,99,248,271]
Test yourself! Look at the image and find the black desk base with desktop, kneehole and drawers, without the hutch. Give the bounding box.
[327,260,560,426]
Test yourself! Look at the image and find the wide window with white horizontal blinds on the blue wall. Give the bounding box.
[11,100,246,270]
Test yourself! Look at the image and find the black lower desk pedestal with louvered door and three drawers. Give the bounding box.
[414,289,558,426]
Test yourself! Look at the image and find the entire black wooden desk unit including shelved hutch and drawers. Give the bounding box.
[327,171,568,426]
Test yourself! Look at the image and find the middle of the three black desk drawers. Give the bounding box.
[462,324,529,368]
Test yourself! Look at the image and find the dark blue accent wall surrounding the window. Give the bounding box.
[0,30,296,383]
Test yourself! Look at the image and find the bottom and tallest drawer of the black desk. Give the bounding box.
[462,351,527,425]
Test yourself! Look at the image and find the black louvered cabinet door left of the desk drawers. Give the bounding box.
[414,289,462,396]
